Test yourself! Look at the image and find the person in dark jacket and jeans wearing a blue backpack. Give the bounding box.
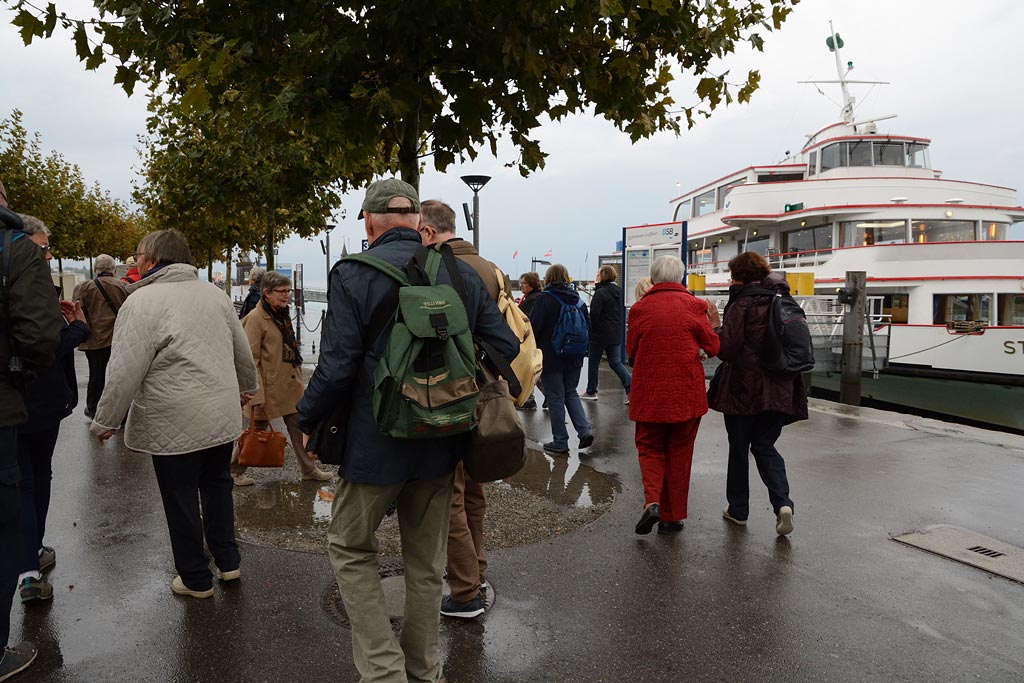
[529,263,594,455]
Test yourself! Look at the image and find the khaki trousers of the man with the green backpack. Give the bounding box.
[327,474,454,683]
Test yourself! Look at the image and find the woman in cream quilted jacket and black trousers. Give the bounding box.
[90,230,258,598]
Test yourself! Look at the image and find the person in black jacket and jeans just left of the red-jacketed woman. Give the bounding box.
[582,265,631,403]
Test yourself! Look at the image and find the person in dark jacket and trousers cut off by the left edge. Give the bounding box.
[0,183,61,679]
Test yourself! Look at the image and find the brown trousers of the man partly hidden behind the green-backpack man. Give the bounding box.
[447,462,487,602]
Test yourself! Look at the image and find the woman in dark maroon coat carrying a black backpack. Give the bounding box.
[708,252,807,536]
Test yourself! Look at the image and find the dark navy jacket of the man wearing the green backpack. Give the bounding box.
[298,227,519,485]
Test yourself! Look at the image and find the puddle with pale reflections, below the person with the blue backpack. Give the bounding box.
[499,450,618,508]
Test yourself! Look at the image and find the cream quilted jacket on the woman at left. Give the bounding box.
[91,263,258,456]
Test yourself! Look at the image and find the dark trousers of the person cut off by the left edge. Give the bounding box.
[0,427,22,647]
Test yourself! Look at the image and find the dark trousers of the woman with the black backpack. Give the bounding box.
[725,413,794,519]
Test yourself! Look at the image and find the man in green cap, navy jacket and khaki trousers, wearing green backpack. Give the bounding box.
[298,178,519,681]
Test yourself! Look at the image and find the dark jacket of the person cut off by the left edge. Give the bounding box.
[0,215,63,427]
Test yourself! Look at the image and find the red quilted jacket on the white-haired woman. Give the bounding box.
[626,283,719,422]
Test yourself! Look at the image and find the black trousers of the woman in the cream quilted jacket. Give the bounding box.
[153,443,242,591]
